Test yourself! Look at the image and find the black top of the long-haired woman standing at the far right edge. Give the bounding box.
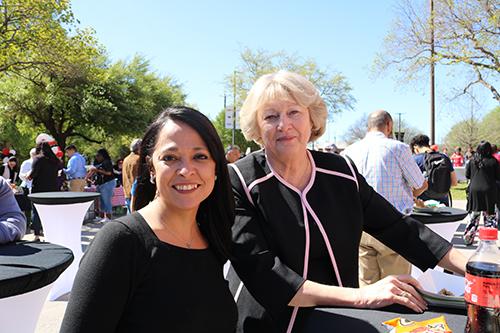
[465,157,500,214]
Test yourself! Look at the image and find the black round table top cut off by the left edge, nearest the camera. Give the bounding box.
[0,241,73,298]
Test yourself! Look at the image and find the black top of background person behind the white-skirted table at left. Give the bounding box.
[31,156,60,193]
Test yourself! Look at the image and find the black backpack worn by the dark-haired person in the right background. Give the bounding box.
[424,152,451,199]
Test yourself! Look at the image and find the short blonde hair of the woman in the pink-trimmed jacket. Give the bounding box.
[240,71,328,145]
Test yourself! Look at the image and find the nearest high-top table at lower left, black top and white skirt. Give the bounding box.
[0,241,73,333]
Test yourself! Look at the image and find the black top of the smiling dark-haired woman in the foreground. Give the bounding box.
[61,213,237,333]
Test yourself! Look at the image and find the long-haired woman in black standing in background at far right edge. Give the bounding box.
[463,141,500,245]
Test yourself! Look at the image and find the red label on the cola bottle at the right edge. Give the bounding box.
[464,273,500,309]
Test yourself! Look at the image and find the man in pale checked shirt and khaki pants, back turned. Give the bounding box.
[343,110,427,287]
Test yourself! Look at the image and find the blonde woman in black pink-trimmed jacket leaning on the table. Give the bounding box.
[228,71,466,332]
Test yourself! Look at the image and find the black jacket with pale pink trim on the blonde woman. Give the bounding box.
[228,151,451,333]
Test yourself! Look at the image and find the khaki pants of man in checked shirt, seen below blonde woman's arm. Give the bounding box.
[359,232,411,287]
